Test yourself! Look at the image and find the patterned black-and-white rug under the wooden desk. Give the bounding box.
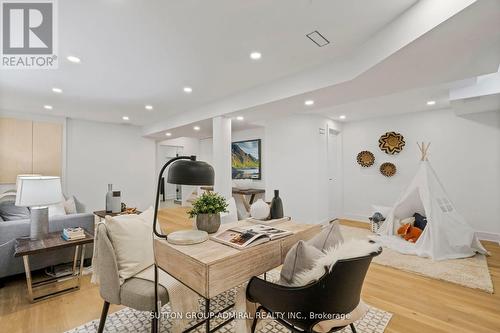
[66,289,392,333]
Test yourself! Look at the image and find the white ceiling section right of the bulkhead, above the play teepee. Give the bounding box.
[214,1,500,122]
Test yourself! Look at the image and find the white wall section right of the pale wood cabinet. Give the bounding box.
[66,119,156,211]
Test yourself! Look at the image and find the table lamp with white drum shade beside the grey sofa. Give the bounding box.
[16,176,63,240]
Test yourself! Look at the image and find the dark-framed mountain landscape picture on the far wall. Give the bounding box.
[231,139,262,179]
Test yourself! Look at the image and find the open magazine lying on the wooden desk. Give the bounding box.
[210,224,293,250]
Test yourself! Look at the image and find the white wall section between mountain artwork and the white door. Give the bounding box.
[263,115,339,223]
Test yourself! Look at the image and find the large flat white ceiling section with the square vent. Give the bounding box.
[0,0,417,125]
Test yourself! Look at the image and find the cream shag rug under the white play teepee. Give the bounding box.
[340,225,493,293]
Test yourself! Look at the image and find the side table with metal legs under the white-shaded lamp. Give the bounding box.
[14,231,94,302]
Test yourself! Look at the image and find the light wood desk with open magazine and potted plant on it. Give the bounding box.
[155,221,321,332]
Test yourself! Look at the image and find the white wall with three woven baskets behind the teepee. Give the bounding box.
[343,110,500,233]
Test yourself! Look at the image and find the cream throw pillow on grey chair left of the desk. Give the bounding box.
[106,208,154,282]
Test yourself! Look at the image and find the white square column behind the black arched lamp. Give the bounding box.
[212,116,232,199]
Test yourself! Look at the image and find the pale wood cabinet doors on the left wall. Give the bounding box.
[0,118,63,184]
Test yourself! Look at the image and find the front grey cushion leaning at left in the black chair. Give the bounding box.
[279,241,323,285]
